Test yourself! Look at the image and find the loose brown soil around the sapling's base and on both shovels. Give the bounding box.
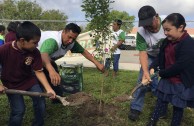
[66,92,128,126]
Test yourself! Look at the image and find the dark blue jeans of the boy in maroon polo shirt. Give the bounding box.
[7,84,45,126]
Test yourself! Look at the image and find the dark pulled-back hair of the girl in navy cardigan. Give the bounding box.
[162,13,186,30]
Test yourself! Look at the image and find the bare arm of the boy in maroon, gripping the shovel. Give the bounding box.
[35,71,56,98]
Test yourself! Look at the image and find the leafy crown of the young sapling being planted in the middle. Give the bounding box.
[81,0,114,62]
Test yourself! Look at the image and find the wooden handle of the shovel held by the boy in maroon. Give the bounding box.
[5,89,52,97]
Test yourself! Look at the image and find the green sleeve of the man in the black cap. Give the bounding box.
[136,33,147,51]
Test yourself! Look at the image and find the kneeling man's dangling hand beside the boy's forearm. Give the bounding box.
[49,71,61,86]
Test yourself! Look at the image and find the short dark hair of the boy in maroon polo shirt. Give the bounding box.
[16,21,41,41]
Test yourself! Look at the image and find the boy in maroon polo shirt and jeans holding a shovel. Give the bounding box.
[0,21,56,126]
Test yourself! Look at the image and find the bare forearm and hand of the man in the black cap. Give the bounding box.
[139,51,151,81]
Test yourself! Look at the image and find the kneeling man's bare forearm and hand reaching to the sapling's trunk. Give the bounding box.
[82,50,104,72]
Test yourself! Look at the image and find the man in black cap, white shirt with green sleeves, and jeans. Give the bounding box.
[128,5,165,121]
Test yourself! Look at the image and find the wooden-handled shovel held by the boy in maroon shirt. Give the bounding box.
[5,89,70,106]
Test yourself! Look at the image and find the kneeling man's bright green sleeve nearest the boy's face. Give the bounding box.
[40,38,58,55]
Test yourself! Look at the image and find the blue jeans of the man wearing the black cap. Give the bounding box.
[130,57,158,111]
